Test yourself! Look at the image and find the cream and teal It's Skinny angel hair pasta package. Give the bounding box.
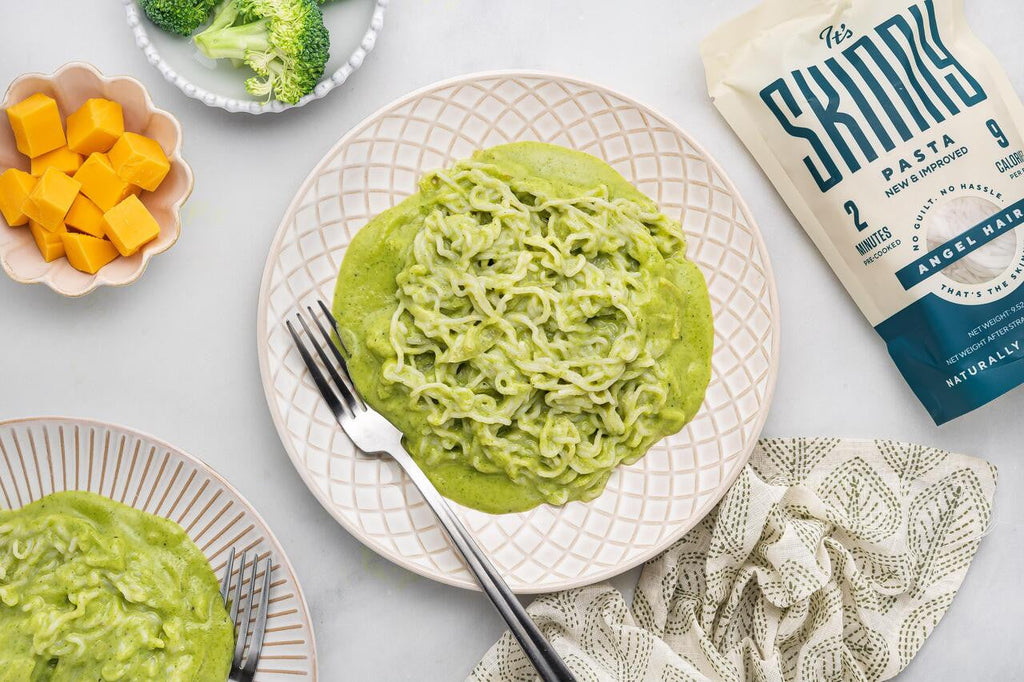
[701,0,1024,424]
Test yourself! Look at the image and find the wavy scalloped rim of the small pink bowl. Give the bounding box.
[0,61,196,298]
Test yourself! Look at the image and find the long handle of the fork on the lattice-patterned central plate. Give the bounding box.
[389,447,575,682]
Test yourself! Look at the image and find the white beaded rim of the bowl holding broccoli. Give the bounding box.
[122,0,390,115]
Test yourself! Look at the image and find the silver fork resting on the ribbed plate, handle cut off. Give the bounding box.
[220,547,273,682]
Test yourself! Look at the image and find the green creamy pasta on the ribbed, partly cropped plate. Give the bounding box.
[0,492,233,682]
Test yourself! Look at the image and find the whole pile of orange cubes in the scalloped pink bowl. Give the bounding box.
[7,93,171,274]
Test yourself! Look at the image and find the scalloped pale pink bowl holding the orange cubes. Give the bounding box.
[0,61,193,296]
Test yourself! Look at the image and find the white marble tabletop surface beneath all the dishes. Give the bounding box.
[0,0,1024,682]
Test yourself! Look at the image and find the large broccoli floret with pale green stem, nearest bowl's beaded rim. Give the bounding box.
[196,0,331,104]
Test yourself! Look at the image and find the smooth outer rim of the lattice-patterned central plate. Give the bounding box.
[256,70,781,595]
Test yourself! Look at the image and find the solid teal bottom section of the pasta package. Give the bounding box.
[874,288,1024,424]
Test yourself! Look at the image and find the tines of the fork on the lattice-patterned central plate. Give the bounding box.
[286,300,366,419]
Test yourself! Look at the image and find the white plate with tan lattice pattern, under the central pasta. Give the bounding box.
[257,73,778,593]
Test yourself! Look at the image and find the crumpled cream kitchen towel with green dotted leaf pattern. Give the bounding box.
[469,438,996,682]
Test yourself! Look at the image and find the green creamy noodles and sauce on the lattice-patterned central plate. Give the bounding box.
[334,142,713,513]
